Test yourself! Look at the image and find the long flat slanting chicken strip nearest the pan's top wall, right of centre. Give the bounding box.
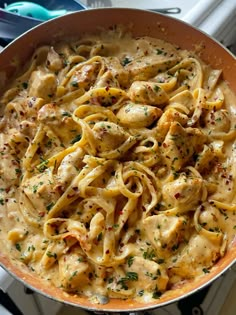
[125,55,179,81]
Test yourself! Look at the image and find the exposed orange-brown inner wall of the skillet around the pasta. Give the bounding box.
[0,8,236,312]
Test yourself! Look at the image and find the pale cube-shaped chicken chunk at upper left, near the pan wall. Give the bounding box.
[29,69,57,101]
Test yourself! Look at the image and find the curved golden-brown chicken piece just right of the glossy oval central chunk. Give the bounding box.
[157,108,188,139]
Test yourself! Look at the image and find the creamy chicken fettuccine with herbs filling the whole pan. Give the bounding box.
[0,28,236,303]
